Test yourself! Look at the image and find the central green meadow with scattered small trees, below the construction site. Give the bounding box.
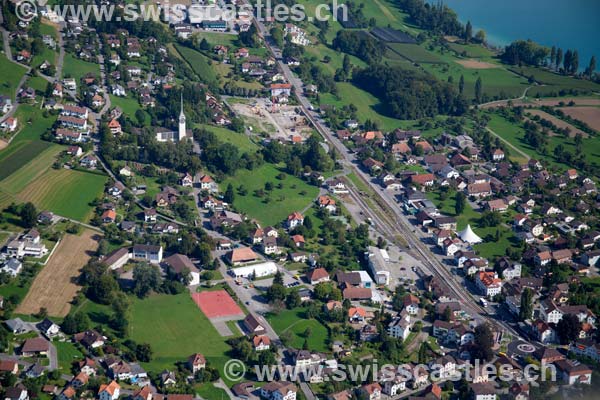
[220,164,319,226]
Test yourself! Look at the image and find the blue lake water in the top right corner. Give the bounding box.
[443,0,600,69]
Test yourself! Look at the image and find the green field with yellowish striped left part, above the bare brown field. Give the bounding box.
[18,169,107,221]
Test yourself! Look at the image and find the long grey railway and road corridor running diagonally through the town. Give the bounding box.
[248,14,521,338]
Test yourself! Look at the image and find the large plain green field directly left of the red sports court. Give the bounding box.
[130,293,229,373]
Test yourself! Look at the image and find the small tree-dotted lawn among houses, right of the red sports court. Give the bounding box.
[266,309,329,351]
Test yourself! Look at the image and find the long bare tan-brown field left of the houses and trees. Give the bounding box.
[16,230,99,317]
